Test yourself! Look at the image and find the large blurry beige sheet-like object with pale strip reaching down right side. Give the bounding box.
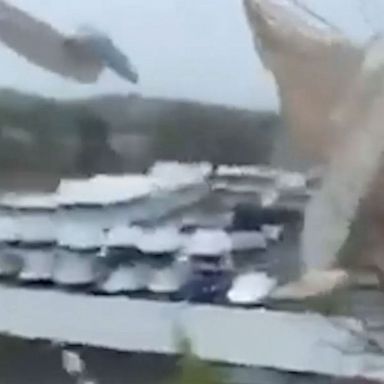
[244,0,384,298]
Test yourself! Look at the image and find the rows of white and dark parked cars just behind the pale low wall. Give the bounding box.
[0,207,300,305]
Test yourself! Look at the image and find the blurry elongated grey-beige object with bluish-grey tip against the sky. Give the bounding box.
[0,0,138,83]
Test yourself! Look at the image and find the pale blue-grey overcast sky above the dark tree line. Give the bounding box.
[0,0,384,109]
